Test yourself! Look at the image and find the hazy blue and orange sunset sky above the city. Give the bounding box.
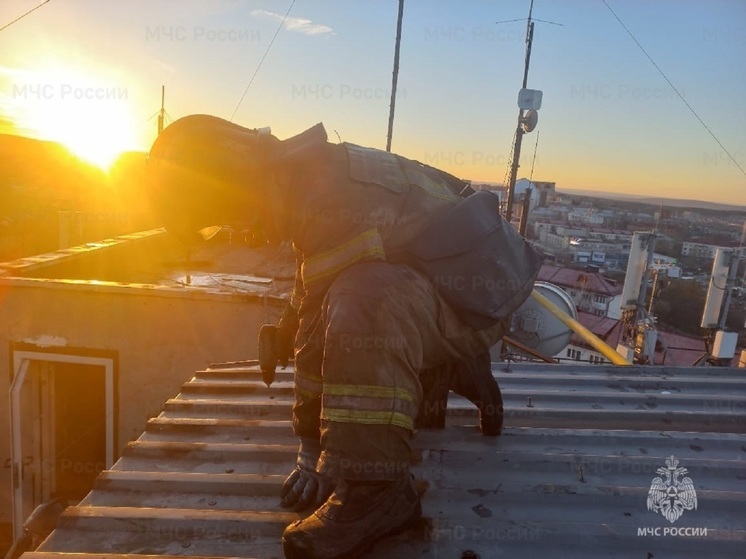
[0,0,746,205]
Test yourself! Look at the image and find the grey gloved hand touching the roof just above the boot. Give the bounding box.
[280,437,334,512]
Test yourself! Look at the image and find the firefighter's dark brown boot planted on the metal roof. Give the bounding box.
[282,474,422,559]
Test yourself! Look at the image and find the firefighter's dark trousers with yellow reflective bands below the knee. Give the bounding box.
[293,261,504,480]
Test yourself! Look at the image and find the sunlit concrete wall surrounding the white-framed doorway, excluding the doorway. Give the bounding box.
[0,230,283,522]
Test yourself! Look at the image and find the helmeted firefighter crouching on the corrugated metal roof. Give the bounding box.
[148,115,532,559]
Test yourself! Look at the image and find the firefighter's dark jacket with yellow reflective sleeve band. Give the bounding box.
[278,124,469,301]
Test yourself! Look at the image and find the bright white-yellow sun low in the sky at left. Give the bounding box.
[4,66,141,171]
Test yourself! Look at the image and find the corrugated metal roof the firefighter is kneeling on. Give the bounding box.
[26,363,746,559]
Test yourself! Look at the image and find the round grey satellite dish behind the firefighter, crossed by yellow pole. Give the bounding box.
[508,281,578,357]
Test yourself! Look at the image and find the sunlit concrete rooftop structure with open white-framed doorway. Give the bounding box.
[0,230,294,548]
